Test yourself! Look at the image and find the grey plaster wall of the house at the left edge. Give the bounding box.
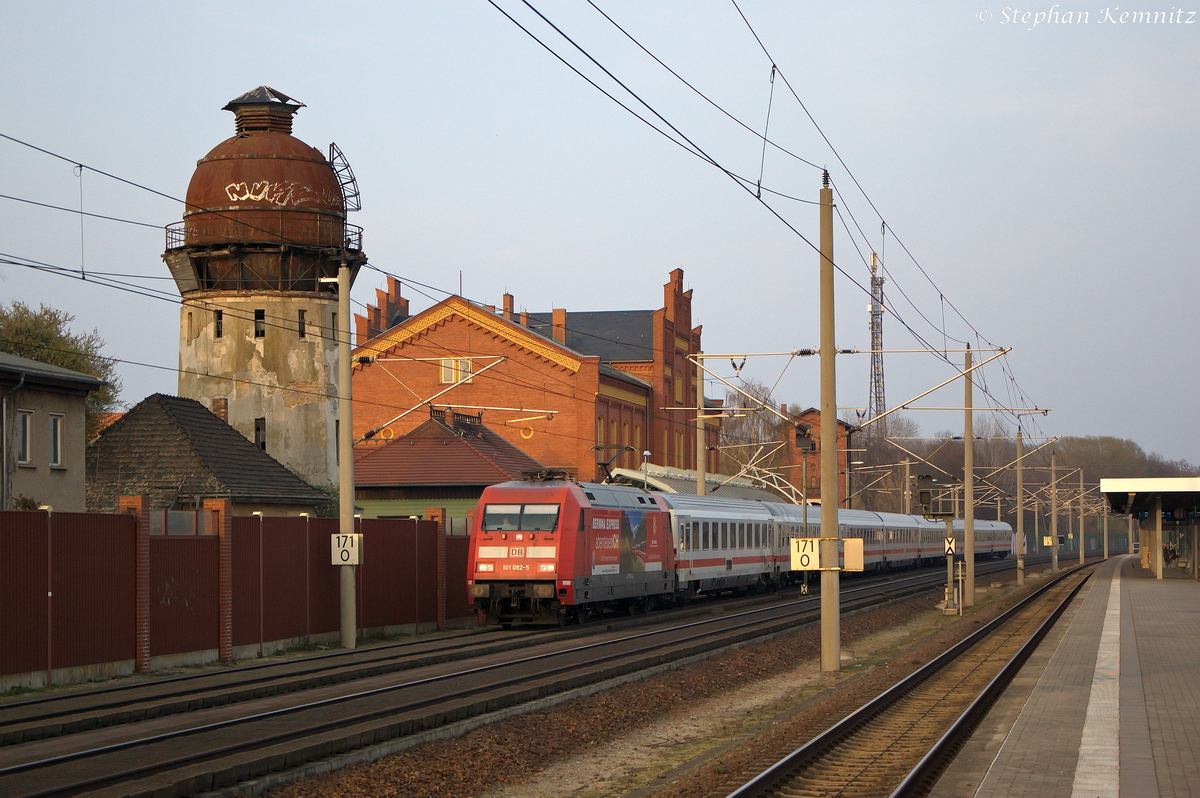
[0,388,86,512]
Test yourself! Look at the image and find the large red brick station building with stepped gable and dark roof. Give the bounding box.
[354,269,719,480]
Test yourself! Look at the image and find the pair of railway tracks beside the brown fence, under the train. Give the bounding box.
[0,554,1036,798]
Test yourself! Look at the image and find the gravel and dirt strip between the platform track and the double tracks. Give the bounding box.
[269,566,1042,798]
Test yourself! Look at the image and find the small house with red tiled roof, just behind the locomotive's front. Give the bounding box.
[354,409,542,525]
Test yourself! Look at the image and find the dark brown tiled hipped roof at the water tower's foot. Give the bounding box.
[88,394,329,515]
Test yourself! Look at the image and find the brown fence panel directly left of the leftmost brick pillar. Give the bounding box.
[50,512,137,667]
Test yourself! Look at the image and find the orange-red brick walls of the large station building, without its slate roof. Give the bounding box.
[354,269,720,480]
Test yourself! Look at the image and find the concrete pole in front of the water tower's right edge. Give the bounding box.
[337,260,358,649]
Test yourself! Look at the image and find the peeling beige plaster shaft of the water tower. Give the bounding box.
[179,292,344,485]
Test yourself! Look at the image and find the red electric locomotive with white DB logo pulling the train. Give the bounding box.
[467,479,676,626]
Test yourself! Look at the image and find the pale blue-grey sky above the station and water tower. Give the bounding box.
[0,0,1200,463]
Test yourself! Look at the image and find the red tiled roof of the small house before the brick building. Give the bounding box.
[354,416,542,487]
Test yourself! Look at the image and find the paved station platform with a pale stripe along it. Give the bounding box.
[930,554,1200,798]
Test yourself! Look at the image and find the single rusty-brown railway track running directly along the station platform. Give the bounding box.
[728,566,1091,798]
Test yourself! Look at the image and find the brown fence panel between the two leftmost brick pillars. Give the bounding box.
[150,535,220,656]
